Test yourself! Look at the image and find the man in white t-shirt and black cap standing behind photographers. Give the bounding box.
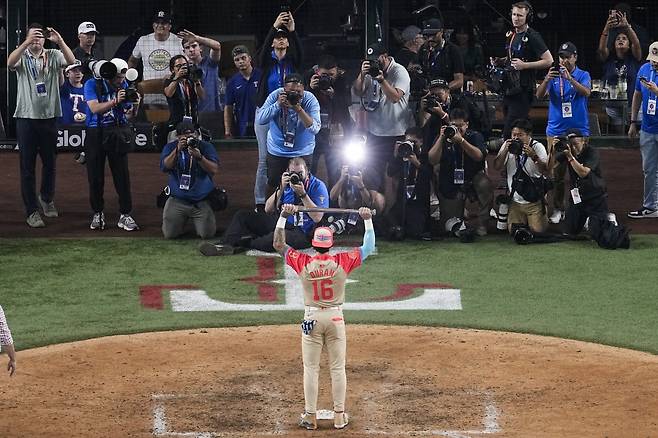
[128,11,183,107]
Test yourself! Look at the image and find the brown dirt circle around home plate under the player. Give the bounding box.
[0,325,658,438]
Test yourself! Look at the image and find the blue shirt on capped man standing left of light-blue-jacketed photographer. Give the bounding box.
[226,68,263,137]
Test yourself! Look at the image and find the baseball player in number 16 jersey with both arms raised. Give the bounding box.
[274,204,375,430]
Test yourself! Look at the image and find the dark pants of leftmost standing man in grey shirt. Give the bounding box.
[16,119,57,216]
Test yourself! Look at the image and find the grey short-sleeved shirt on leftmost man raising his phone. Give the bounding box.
[10,49,67,119]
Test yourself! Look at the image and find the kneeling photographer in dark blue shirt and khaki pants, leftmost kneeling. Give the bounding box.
[160,122,219,239]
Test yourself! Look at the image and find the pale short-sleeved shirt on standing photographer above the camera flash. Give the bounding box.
[364,58,411,137]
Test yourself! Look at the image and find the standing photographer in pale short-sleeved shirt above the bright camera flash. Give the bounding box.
[352,43,411,201]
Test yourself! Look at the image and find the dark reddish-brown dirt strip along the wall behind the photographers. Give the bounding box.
[0,148,658,237]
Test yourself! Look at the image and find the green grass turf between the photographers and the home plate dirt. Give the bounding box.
[0,236,658,354]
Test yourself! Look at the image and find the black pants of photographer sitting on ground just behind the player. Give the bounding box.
[222,210,311,252]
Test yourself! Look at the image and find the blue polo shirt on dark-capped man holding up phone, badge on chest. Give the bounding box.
[546,67,592,137]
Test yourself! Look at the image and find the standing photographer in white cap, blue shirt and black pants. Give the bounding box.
[85,58,140,231]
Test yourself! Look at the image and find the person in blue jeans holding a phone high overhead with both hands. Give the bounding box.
[254,12,303,211]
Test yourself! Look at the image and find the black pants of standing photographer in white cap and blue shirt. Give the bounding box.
[85,128,133,214]
